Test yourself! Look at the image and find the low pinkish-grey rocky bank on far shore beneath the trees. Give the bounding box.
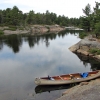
[0,25,65,35]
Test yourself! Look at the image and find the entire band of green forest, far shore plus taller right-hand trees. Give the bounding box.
[0,2,100,36]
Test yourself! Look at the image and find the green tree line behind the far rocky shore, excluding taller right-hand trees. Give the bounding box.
[0,6,79,26]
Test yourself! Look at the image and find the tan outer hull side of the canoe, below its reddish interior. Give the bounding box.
[35,71,100,85]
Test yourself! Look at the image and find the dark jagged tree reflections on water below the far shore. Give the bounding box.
[0,31,69,53]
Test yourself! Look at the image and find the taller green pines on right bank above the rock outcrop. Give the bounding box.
[80,2,100,37]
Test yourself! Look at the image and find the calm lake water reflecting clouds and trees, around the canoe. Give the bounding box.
[0,31,100,100]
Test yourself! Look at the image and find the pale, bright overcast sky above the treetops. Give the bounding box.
[0,0,100,18]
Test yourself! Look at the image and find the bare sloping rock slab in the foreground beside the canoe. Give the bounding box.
[56,78,100,100]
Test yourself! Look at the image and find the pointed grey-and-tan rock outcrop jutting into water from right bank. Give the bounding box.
[69,35,100,61]
